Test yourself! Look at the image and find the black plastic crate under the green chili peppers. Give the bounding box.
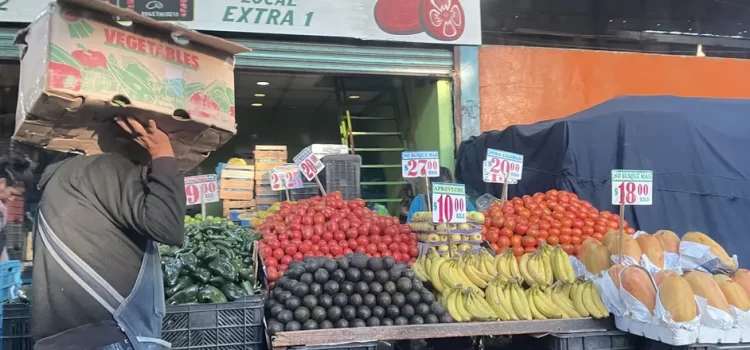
[161,296,264,350]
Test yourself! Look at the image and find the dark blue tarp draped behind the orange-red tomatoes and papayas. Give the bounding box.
[456,96,750,267]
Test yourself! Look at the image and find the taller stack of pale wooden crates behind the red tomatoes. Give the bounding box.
[255,145,287,208]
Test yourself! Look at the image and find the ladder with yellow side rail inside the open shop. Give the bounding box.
[334,77,409,206]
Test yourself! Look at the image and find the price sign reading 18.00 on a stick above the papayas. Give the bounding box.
[612,170,654,205]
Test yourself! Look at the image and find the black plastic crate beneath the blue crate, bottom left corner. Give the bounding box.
[0,304,34,350]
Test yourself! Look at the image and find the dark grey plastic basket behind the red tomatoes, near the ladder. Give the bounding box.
[321,154,362,200]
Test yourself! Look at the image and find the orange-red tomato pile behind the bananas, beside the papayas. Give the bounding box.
[484,190,635,256]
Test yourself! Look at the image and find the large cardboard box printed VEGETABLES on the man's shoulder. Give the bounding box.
[15,0,248,170]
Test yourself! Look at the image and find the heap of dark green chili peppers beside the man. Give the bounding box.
[159,214,260,305]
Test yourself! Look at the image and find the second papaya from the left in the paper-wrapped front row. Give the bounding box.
[659,274,698,322]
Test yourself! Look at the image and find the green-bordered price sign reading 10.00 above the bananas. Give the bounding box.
[432,182,466,223]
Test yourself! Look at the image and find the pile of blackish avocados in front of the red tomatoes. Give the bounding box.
[266,253,453,335]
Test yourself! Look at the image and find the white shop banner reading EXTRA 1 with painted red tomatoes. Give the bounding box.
[0,0,482,45]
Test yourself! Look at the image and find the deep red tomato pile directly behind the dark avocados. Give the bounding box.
[257,192,419,288]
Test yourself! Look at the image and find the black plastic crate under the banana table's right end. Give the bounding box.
[548,331,639,350]
